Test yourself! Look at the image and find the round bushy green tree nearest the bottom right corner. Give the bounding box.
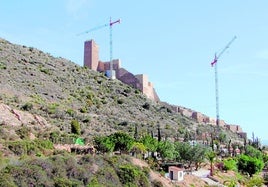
[237,154,264,177]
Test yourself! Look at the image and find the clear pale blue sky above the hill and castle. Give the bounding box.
[0,0,268,143]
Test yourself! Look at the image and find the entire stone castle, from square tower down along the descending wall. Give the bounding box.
[84,40,247,137]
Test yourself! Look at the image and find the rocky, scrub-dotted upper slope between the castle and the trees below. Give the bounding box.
[0,39,243,143]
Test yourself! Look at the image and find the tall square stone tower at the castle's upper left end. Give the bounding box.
[84,40,99,71]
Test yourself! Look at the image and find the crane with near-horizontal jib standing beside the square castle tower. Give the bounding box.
[78,17,121,79]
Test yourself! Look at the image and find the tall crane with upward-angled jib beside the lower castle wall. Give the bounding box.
[210,36,236,127]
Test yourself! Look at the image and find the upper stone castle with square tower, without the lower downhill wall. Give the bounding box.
[84,40,160,101]
